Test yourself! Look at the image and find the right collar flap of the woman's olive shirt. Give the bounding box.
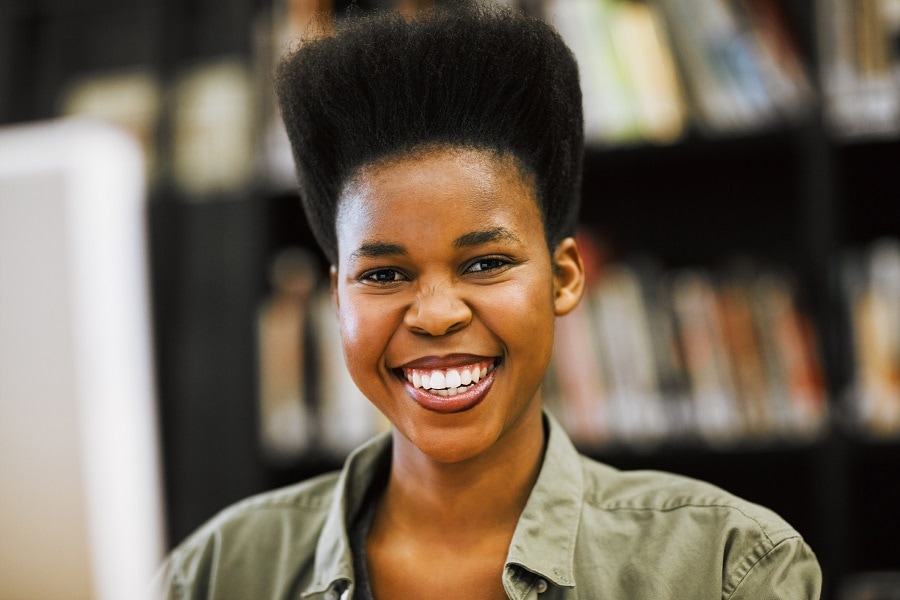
[506,411,584,586]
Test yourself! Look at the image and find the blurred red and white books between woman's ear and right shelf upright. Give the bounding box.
[545,243,829,447]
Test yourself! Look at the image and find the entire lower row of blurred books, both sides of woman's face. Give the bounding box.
[251,239,900,461]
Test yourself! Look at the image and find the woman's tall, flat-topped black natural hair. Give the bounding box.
[275,6,584,262]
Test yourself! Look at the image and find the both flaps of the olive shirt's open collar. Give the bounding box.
[303,411,584,597]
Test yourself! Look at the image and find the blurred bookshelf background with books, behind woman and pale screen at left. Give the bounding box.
[0,0,900,600]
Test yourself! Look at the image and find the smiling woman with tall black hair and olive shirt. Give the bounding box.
[153,8,821,600]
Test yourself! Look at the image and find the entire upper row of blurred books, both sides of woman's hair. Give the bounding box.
[59,0,900,199]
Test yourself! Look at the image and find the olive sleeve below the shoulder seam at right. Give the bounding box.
[722,536,822,600]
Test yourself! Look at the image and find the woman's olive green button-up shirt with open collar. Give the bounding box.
[155,416,821,600]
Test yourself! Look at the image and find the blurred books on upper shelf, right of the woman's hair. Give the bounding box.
[540,0,900,144]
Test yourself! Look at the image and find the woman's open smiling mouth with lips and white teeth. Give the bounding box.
[396,358,500,413]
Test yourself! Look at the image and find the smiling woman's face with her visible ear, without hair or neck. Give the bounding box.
[333,149,582,462]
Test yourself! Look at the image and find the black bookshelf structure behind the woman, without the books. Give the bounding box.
[0,0,900,598]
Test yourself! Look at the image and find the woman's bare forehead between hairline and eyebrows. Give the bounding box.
[336,148,543,253]
